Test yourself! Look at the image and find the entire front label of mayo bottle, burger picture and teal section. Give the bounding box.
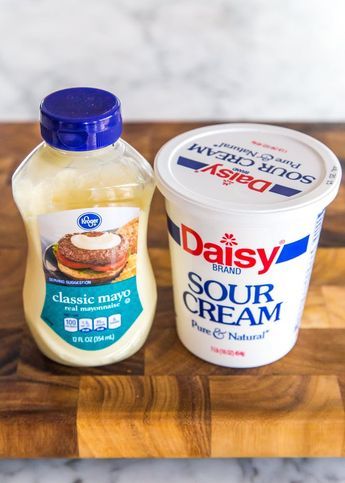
[38,207,143,351]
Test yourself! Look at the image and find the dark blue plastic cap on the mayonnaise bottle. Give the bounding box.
[40,87,122,151]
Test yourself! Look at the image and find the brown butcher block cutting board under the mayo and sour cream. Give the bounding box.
[0,123,345,458]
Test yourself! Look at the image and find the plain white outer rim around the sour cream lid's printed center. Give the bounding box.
[154,123,341,214]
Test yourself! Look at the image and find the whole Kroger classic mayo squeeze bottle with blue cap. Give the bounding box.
[13,88,156,366]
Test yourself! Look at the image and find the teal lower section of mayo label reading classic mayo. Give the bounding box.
[41,277,142,350]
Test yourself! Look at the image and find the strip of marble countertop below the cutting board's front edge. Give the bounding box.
[0,458,345,483]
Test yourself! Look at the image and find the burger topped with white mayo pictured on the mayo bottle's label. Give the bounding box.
[53,231,129,282]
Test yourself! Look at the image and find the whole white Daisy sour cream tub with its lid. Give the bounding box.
[155,124,341,368]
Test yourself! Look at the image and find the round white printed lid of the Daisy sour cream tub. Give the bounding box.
[155,123,341,213]
